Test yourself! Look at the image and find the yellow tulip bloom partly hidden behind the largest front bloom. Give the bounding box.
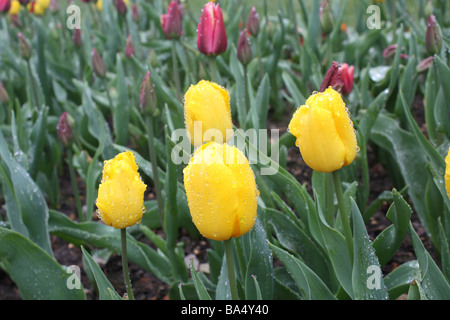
[184,80,233,147]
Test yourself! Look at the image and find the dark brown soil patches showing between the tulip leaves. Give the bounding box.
[0,95,437,300]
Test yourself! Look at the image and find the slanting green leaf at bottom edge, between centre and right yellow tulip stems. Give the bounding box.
[269,243,336,300]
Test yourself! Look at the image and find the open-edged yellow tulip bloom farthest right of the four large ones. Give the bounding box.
[289,88,359,172]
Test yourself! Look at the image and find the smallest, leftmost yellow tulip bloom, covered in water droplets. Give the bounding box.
[97,151,147,229]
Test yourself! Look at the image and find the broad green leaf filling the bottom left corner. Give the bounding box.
[0,227,86,300]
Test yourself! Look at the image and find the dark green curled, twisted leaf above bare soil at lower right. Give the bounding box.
[372,189,411,266]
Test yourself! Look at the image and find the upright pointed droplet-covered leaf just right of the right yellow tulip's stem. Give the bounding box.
[351,199,388,300]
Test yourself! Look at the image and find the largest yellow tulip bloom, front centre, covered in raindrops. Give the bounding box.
[183,142,259,241]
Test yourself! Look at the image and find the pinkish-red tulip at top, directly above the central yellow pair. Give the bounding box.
[197,2,227,55]
